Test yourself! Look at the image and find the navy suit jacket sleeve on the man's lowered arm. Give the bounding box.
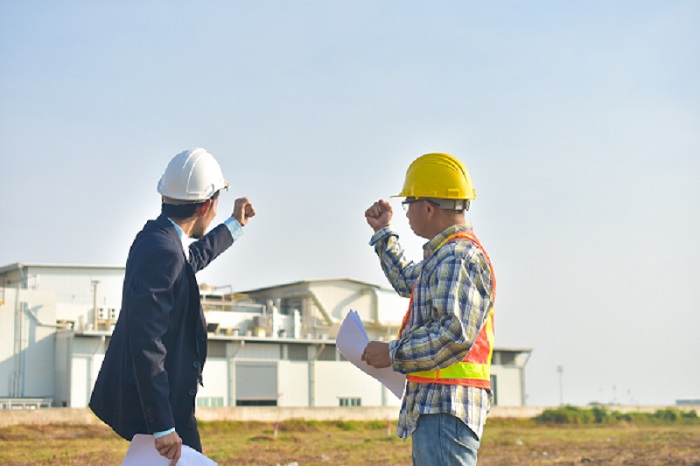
[126,248,185,432]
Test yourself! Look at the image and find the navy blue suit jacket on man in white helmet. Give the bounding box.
[90,215,233,440]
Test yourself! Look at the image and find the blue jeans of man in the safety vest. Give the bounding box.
[412,414,480,466]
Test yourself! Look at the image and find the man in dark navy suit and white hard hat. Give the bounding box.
[90,149,255,466]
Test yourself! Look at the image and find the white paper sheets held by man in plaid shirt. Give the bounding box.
[335,310,406,399]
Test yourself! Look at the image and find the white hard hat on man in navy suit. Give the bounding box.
[158,147,228,202]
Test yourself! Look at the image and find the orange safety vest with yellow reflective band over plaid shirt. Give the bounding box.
[399,231,496,389]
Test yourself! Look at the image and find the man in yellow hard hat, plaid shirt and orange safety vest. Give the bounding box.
[362,153,496,466]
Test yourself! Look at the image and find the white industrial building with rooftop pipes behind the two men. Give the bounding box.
[0,263,531,408]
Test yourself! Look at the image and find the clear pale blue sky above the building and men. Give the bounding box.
[0,0,700,405]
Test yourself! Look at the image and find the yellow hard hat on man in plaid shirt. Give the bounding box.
[392,153,476,200]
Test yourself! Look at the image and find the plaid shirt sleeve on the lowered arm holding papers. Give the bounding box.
[389,243,492,373]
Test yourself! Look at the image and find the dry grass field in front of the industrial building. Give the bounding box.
[0,419,700,466]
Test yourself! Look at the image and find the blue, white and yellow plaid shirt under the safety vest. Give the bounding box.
[370,224,493,439]
